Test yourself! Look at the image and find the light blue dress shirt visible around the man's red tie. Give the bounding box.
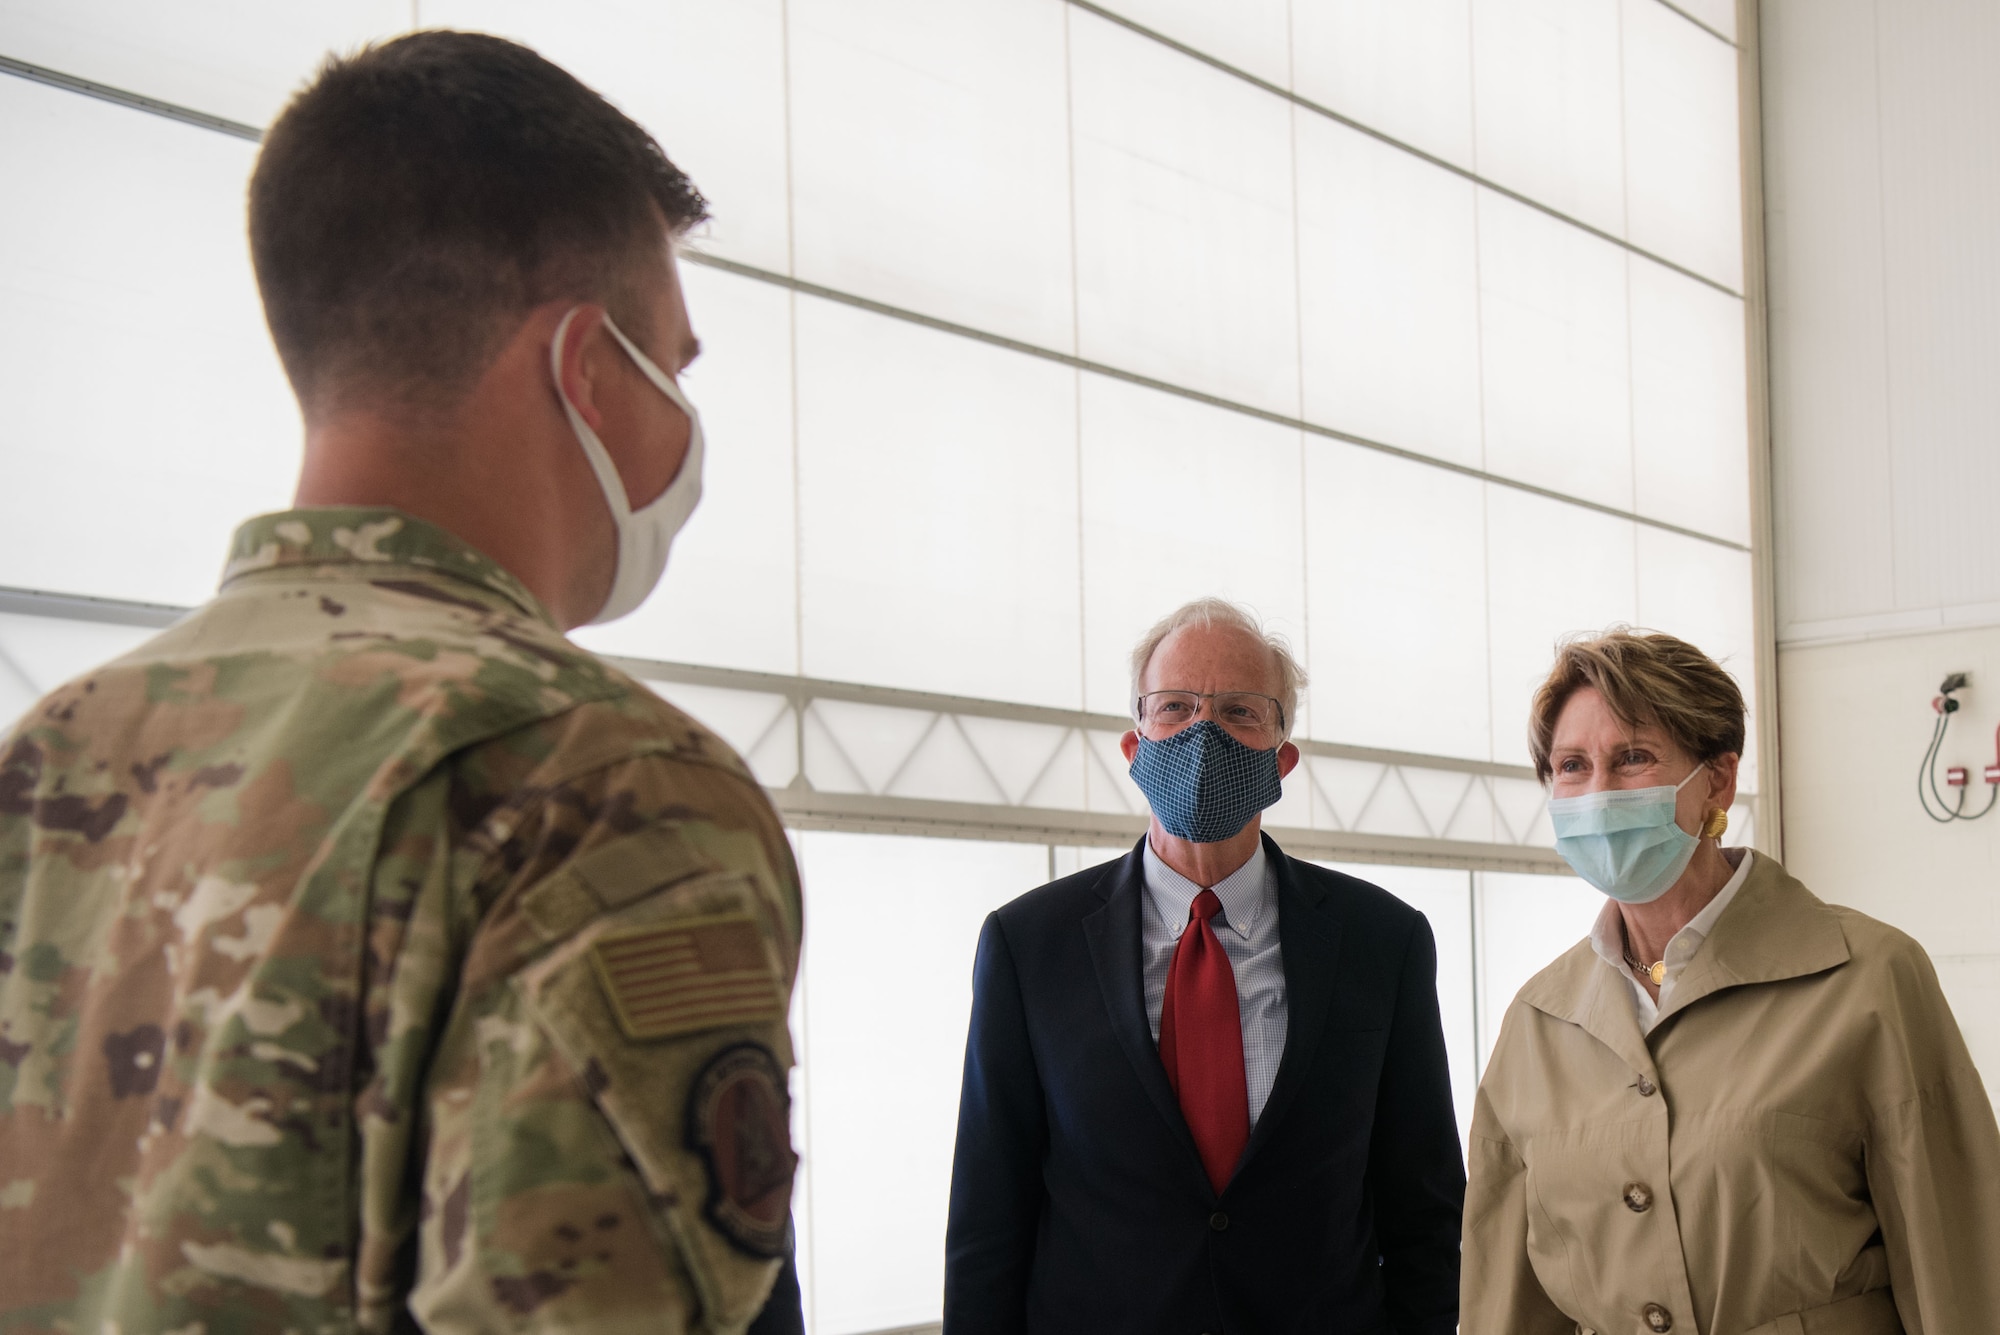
[1138,839,1286,1129]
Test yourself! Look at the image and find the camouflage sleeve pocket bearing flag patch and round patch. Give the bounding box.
[518,873,798,1329]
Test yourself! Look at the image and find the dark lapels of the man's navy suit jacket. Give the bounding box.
[1084,835,1340,1191]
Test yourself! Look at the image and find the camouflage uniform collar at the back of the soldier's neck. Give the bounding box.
[222,506,562,630]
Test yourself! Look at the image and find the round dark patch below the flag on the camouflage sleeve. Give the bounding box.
[688,1043,798,1259]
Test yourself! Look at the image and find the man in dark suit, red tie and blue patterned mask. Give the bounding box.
[944,600,1466,1335]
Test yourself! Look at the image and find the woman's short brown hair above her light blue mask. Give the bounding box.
[1528,626,1744,783]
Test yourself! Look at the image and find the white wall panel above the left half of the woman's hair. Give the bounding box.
[1486,484,1638,765]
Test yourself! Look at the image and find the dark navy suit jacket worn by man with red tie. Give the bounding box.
[944,835,1466,1335]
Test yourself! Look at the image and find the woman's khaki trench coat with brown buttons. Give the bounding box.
[1460,855,2000,1335]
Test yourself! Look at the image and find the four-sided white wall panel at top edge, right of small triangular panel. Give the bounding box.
[1288,0,1472,166]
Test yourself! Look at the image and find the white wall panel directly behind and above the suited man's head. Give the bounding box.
[1082,376,1310,721]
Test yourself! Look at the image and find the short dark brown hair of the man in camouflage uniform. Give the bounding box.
[250,32,708,414]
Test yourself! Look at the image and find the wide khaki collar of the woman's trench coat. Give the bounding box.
[1520,853,1848,1073]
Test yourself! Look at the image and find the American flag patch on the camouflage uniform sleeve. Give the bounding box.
[590,913,784,1039]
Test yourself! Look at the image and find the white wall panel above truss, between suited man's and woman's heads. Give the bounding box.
[1306,438,1492,759]
